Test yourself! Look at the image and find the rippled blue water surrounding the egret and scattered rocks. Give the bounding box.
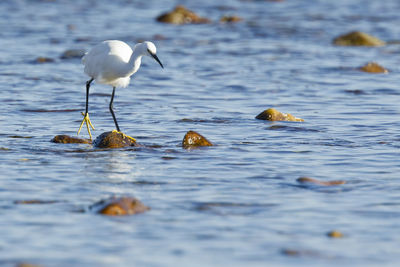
[0,0,400,266]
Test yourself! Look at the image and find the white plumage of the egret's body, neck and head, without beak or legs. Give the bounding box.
[82,40,156,87]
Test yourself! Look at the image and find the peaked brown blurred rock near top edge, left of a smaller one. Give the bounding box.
[157,5,211,24]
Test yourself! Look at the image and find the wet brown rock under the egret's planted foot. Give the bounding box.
[93,130,140,148]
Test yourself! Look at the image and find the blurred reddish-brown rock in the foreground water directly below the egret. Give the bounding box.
[91,197,150,216]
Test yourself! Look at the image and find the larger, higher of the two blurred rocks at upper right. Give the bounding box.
[333,31,386,46]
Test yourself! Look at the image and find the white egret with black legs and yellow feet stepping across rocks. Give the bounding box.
[77,40,164,140]
